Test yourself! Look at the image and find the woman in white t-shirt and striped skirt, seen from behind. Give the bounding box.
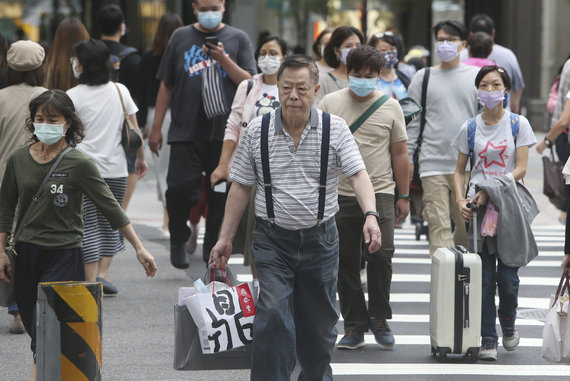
[67,40,148,294]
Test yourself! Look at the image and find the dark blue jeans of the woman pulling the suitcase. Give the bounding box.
[480,247,519,345]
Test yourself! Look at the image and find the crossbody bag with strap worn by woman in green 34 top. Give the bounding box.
[0,147,73,307]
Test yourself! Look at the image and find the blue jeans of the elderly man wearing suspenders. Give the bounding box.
[251,218,338,381]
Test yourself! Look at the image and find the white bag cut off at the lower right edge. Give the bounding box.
[542,269,570,362]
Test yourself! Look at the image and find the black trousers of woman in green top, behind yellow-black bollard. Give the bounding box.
[16,242,85,355]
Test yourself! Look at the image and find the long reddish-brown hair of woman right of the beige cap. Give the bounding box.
[44,16,89,91]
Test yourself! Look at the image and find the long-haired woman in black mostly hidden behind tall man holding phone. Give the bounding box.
[140,13,181,239]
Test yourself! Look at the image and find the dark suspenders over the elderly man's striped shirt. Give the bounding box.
[261,112,331,225]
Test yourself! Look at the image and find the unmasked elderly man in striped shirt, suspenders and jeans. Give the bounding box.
[210,55,381,381]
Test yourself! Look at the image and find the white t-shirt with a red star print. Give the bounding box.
[451,110,536,197]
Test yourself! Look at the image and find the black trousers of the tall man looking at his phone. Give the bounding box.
[166,141,227,262]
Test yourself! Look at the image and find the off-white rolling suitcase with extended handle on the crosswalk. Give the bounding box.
[429,206,482,362]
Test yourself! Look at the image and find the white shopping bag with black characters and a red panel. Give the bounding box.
[184,282,255,354]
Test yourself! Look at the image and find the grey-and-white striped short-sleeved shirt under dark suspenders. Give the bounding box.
[230,107,365,230]
